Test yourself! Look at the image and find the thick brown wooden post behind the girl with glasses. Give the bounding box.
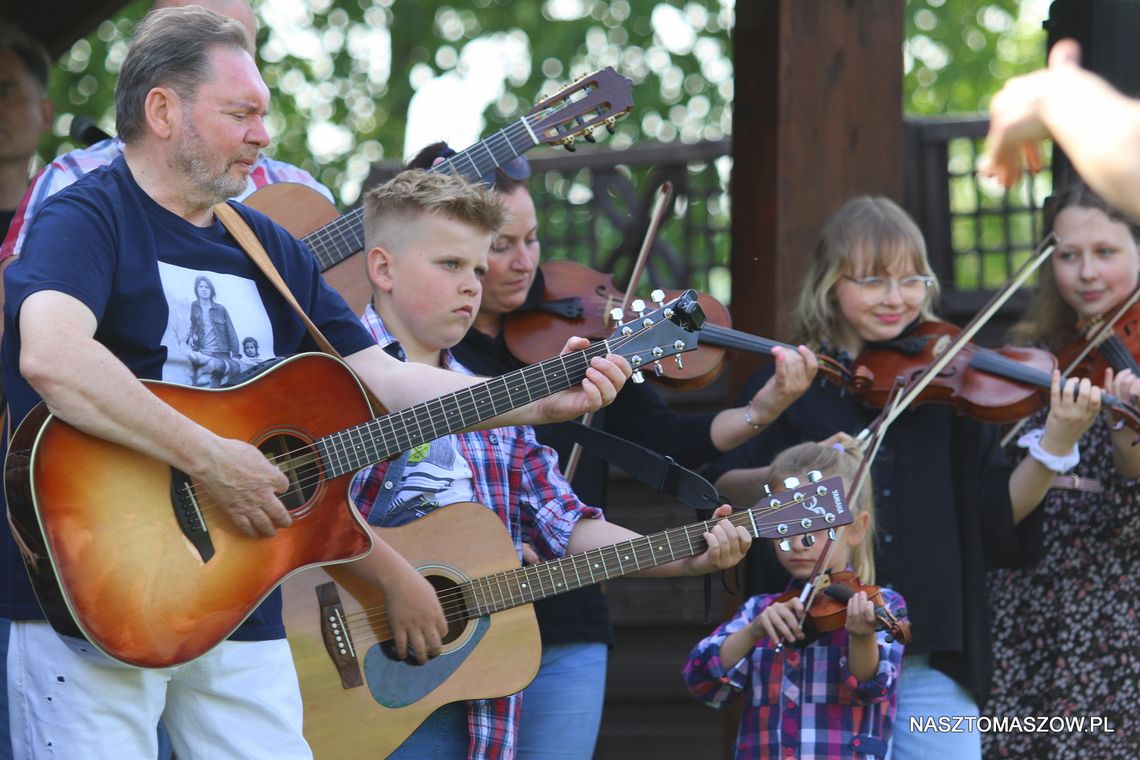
[732,0,905,390]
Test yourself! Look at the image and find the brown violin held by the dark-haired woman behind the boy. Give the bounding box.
[503,261,848,389]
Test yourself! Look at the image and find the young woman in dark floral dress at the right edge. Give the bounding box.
[984,185,1140,758]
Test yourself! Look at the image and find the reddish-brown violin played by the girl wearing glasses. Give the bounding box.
[850,321,1140,430]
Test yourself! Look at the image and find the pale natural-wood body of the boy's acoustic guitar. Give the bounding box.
[283,502,542,760]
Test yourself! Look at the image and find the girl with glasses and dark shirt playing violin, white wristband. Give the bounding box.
[709,196,1100,760]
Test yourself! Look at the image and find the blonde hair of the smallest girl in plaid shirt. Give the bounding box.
[768,442,874,583]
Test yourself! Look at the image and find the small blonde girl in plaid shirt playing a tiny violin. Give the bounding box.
[684,443,903,759]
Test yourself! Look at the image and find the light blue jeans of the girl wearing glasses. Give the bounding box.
[887,654,982,760]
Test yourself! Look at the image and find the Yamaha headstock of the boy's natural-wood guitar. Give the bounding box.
[746,469,854,548]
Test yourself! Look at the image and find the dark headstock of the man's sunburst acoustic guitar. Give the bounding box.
[606,291,705,383]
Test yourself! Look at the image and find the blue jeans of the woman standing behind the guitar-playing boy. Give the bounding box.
[519,641,609,760]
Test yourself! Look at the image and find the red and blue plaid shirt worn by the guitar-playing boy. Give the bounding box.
[350,307,602,760]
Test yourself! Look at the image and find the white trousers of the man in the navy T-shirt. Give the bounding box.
[8,621,312,760]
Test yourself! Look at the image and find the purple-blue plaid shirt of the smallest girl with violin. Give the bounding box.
[683,588,905,760]
